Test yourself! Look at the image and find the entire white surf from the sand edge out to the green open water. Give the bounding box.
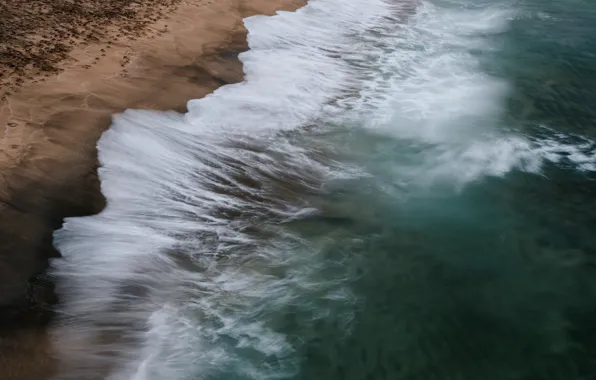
[52,0,594,380]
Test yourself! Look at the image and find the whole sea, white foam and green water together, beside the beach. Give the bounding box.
[52,0,596,380]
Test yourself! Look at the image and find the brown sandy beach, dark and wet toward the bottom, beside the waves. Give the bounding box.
[0,0,304,380]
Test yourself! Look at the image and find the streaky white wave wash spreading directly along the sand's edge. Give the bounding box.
[52,0,402,380]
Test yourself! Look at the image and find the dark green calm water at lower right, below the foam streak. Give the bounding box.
[294,167,596,380]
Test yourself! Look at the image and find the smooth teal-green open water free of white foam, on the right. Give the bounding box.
[288,0,596,380]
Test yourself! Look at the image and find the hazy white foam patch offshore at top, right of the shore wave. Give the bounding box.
[336,3,511,138]
